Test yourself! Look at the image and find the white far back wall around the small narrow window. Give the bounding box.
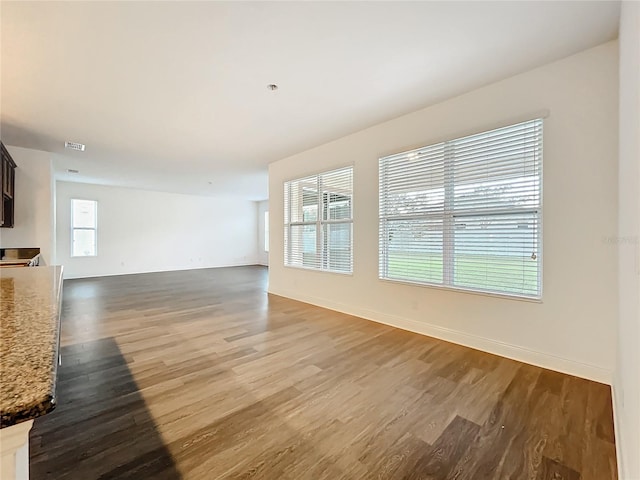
[56,182,257,278]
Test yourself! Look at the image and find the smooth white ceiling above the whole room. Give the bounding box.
[0,1,620,200]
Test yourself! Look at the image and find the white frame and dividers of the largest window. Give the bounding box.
[378,117,544,303]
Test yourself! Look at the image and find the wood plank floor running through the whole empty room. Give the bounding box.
[30,267,616,480]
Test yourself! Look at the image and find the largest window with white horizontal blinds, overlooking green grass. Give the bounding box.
[379,119,543,298]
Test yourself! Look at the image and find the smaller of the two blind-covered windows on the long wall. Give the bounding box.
[284,167,353,273]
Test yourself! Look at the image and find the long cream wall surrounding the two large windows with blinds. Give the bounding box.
[269,42,618,382]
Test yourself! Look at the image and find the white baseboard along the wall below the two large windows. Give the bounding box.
[269,289,613,385]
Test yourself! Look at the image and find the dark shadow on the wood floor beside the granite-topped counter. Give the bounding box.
[30,338,180,480]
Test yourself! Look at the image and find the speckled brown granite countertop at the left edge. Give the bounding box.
[0,266,62,428]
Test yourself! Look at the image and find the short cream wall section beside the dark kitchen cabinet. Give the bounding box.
[0,145,55,265]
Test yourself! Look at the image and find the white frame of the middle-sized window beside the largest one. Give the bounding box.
[283,164,354,275]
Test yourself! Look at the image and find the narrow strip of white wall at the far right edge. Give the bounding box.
[614,2,640,480]
